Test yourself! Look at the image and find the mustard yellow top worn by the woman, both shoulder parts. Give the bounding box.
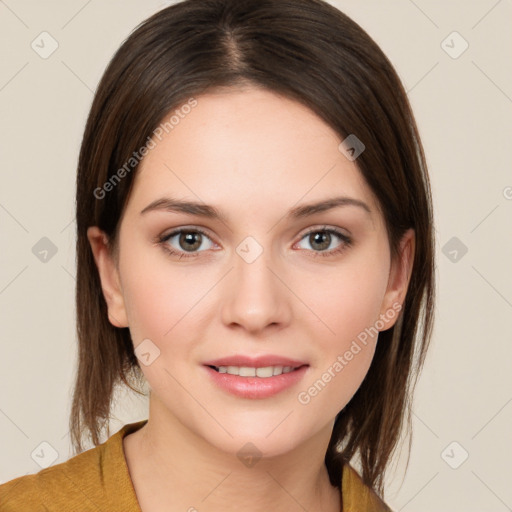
[0,420,391,512]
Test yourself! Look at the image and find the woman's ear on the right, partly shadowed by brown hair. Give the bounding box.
[379,228,416,331]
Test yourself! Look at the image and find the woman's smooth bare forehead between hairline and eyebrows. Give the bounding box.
[124,87,376,222]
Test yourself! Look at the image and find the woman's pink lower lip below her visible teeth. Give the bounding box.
[204,366,309,398]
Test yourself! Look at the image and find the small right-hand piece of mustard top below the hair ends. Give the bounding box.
[341,464,393,512]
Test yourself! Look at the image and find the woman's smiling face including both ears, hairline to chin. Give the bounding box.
[88,88,413,456]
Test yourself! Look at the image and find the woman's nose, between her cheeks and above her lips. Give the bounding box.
[221,243,293,335]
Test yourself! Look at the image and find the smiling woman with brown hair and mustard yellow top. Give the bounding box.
[0,0,434,512]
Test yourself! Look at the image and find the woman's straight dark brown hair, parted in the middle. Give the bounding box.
[70,0,435,495]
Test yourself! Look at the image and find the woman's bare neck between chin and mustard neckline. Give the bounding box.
[124,394,341,512]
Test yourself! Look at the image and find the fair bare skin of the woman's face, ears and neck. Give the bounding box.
[88,87,414,512]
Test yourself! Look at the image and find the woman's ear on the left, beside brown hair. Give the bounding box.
[87,226,128,327]
